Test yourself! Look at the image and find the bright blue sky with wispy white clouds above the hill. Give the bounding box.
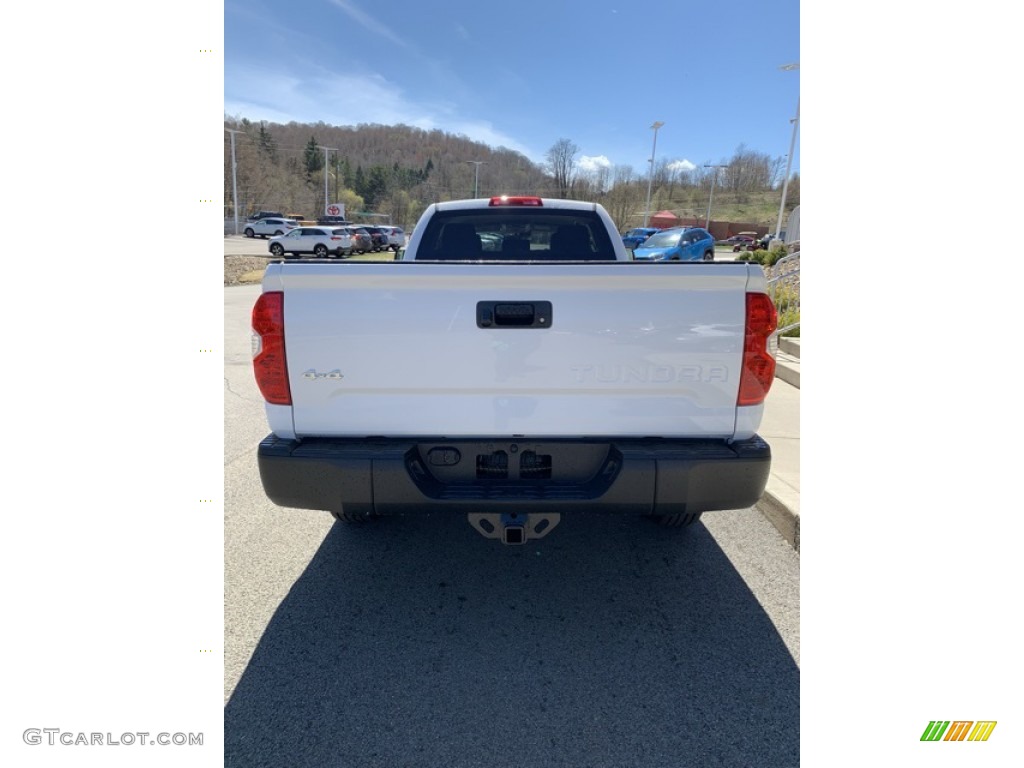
[224,0,800,174]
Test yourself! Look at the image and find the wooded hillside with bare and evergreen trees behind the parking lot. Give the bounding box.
[224,117,799,227]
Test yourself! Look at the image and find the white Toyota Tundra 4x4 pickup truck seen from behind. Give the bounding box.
[253,197,776,544]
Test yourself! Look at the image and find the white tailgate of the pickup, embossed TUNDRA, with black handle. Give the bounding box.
[263,262,764,437]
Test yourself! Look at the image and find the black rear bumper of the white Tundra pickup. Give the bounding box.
[258,434,771,515]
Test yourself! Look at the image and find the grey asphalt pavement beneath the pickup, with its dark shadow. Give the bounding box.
[224,287,800,768]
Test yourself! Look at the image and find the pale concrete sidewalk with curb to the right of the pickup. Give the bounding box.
[757,339,800,552]
